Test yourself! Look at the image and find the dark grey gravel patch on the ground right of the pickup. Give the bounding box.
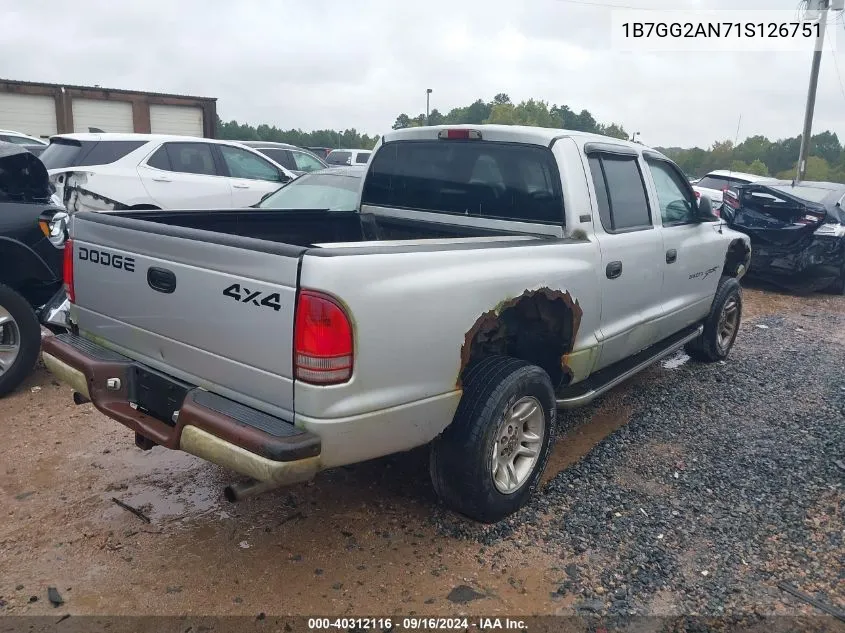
[436,291,845,615]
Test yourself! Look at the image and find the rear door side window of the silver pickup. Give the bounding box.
[589,154,653,233]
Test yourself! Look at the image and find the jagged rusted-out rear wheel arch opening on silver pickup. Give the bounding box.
[457,287,583,388]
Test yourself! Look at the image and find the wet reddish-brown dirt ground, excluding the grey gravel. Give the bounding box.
[0,288,845,616]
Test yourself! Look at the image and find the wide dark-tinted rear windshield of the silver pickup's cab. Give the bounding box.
[362,140,563,224]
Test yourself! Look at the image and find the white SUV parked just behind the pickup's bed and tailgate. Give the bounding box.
[41,133,296,213]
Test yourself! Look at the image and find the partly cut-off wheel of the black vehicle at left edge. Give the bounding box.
[0,285,41,397]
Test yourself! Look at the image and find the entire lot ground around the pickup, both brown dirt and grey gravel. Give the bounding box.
[0,289,845,633]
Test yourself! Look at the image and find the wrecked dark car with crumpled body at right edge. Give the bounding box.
[722,181,845,294]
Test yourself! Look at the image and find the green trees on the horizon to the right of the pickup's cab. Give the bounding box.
[655,131,845,182]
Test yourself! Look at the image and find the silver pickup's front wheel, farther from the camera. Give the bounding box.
[686,277,742,363]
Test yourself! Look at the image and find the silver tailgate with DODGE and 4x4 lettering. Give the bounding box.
[72,213,305,419]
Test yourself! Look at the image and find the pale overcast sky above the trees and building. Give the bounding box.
[0,0,845,147]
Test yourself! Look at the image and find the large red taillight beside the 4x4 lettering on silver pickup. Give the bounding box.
[293,290,352,385]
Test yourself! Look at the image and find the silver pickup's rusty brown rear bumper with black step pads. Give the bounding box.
[42,334,321,484]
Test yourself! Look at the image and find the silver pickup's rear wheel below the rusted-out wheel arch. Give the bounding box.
[430,356,557,523]
